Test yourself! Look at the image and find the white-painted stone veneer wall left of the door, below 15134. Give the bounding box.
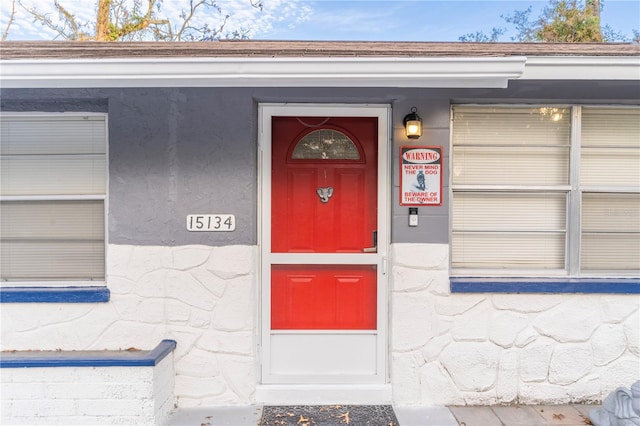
[1,244,257,407]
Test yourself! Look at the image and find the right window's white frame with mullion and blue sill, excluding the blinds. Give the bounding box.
[449,102,640,293]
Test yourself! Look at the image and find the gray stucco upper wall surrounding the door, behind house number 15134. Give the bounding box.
[0,81,640,246]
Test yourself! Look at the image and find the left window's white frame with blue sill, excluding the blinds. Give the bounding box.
[0,111,109,294]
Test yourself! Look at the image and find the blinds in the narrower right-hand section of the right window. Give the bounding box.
[580,107,640,271]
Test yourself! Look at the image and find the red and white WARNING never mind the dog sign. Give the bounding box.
[400,146,442,206]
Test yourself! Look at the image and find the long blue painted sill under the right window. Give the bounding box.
[450,277,640,294]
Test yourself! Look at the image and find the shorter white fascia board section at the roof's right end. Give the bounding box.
[520,56,640,81]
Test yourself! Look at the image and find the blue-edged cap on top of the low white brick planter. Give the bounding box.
[0,340,176,368]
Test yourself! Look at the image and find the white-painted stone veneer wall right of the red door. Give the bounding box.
[391,244,640,405]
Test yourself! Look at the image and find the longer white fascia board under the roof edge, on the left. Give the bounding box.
[0,56,526,88]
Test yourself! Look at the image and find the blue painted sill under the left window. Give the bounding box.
[0,286,110,303]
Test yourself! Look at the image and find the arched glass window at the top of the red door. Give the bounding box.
[291,129,360,160]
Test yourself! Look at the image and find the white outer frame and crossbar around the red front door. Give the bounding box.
[256,103,391,403]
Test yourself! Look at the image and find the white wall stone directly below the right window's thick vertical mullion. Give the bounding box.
[533,296,600,343]
